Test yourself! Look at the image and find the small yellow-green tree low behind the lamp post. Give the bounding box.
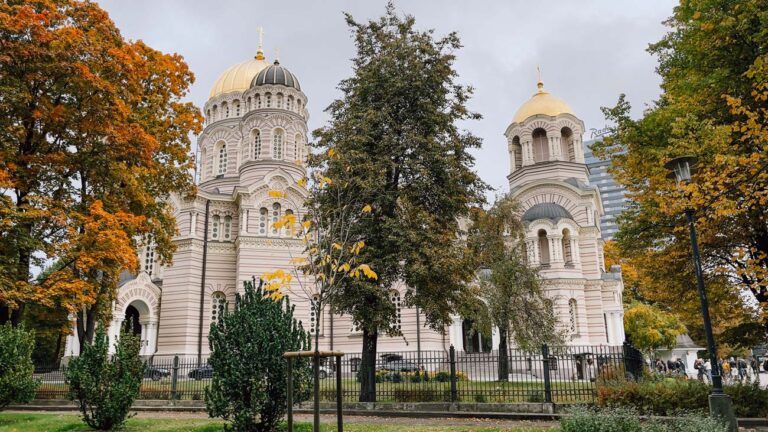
[624,302,686,356]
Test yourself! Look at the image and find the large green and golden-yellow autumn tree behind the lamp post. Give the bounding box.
[595,0,768,325]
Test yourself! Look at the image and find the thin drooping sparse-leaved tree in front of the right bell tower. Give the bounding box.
[469,195,562,381]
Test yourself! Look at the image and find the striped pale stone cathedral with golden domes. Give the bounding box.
[66,49,624,356]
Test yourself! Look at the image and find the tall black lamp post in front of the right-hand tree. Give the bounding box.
[664,156,738,432]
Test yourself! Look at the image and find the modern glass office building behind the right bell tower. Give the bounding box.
[584,140,627,240]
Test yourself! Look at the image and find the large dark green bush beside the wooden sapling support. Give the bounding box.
[205,280,310,431]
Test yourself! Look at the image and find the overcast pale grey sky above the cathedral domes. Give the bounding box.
[99,0,675,196]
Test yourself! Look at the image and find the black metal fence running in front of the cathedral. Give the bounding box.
[36,344,643,403]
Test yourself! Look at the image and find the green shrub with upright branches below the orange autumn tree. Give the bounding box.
[66,326,144,430]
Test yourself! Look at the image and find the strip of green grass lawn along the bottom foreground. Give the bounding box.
[0,413,554,432]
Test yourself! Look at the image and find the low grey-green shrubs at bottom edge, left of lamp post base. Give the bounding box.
[560,407,727,432]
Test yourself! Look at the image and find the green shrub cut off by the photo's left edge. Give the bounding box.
[0,323,39,409]
